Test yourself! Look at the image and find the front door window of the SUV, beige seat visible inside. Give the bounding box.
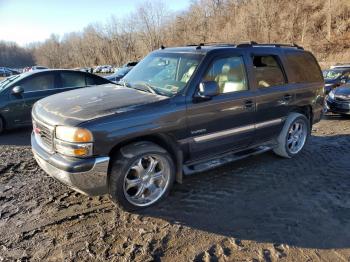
[203,56,248,93]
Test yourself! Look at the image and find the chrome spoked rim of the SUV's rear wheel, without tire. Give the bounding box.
[287,120,307,154]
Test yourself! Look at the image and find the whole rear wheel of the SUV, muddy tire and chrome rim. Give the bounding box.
[273,113,310,158]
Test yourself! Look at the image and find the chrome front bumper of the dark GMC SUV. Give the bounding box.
[31,134,109,196]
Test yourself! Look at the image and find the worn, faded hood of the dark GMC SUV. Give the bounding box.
[33,84,167,126]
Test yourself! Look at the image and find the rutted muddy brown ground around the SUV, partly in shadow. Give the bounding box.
[0,116,350,261]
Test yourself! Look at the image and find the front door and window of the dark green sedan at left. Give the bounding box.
[9,72,57,125]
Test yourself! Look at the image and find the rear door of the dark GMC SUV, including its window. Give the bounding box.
[250,50,295,143]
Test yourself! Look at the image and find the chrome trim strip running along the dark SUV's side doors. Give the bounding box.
[190,118,284,142]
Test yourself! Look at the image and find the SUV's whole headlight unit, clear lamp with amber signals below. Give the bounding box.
[54,126,93,157]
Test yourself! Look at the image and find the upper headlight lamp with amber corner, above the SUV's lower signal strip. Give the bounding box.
[56,126,93,143]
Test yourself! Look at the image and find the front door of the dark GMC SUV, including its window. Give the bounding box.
[187,51,255,160]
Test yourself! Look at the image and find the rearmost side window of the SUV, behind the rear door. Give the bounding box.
[286,52,323,83]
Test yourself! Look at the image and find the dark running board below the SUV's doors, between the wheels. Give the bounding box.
[183,146,272,176]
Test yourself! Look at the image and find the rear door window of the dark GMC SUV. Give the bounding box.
[253,55,286,88]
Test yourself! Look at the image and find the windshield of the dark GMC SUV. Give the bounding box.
[122,53,203,97]
